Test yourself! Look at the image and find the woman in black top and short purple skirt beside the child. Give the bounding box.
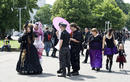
[102,28,118,72]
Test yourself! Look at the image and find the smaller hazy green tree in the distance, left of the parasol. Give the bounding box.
[35,4,52,25]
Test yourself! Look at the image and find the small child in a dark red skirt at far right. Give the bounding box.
[116,43,126,69]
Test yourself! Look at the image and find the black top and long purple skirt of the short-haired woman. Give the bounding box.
[89,35,102,68]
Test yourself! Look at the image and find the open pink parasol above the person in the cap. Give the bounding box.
[53,17,71,33]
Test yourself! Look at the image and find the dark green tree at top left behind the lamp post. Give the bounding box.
[0,0,38,34]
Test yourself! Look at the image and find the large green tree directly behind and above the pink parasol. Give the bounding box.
[52,0,92,27]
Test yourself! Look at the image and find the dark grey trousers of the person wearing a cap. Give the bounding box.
[59,47,71,75]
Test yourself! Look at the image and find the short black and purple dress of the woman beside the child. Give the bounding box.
[104,37,118,55]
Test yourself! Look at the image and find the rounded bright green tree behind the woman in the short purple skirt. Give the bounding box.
[94,0,126,29]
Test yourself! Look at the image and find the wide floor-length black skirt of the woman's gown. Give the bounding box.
[16,44,42,74]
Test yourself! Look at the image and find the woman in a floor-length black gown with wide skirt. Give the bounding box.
[16,24,42,74]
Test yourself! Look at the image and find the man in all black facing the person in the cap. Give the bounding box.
[70,23,83,76]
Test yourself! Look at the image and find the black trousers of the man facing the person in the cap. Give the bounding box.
[70,46,81,72]
